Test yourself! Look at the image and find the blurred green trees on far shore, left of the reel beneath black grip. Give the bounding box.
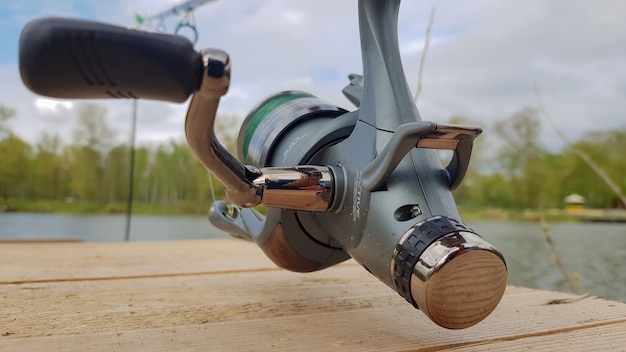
[0,103,224,211]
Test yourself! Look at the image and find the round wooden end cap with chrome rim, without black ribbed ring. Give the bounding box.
[411,232,508,329]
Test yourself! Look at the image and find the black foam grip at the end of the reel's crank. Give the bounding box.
[19,18,203,102]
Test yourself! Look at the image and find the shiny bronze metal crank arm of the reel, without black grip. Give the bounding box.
[185,49,335,211]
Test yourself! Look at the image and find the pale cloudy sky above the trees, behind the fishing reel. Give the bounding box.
[0,0,626,149]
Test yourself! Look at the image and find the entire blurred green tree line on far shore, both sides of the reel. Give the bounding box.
[0,103,626,211]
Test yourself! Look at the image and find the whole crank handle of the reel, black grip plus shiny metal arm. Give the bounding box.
[19,18,334,211]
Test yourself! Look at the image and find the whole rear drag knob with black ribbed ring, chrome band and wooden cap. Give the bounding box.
[392,217,508,329]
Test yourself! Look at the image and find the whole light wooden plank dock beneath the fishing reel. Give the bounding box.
[0,240,626,351]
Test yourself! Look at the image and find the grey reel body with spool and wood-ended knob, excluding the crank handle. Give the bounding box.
[210,1,507,329]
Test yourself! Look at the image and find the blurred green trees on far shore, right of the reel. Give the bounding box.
[456,108,626,209]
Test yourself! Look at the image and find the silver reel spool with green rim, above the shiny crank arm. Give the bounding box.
[237,91,347,167]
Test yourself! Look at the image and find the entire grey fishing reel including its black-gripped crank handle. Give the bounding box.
[20,0,507,329]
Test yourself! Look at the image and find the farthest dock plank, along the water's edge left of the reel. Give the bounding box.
[0,239,275,283]
